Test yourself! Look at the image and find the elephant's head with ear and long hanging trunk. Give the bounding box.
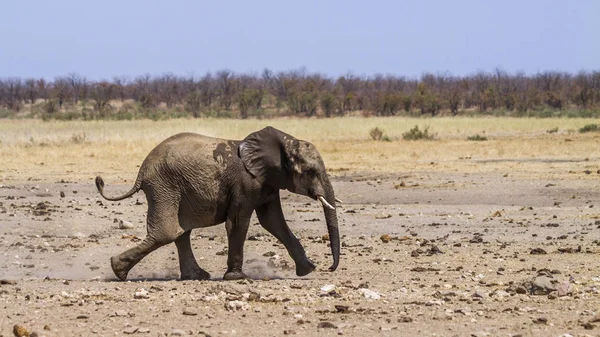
[239,127,340,271]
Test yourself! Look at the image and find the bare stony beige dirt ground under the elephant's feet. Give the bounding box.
[0,151,600,336]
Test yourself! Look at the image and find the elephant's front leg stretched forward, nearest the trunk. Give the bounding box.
[256,194,315,276]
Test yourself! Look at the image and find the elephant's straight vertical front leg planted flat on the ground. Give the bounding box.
[223,210,252,281]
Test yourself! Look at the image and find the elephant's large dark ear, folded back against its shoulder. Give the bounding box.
[238,126,298,186]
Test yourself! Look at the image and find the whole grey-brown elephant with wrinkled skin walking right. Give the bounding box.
[96,127,340,280]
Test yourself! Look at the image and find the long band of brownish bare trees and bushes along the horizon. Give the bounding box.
[0,69,600,119]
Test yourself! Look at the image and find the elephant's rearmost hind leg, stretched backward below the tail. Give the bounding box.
[110,196,183,281]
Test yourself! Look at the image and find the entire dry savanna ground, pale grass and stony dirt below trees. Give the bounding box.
[0,118,600,336]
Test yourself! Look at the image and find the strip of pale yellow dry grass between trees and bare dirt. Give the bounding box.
[0,117,600,183]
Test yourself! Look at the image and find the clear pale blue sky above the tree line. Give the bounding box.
[0,0,600,79]
